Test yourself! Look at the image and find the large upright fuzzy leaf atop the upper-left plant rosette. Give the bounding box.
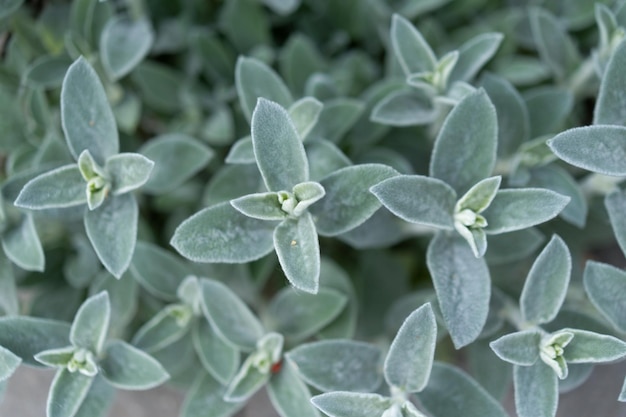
[61,57,119,166]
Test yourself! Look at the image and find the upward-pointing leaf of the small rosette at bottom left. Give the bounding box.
[70,291,111,355]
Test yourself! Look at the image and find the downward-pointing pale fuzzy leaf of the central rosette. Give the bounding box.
[274,212,320,294]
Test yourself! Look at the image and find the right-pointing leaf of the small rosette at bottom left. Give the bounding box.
[99,340,169,390]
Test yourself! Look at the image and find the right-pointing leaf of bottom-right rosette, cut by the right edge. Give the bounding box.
[563,329,626,363]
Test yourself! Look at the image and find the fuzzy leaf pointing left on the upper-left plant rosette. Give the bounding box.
[15,164,87,210]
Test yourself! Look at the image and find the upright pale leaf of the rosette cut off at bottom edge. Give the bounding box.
[384,303,437,393]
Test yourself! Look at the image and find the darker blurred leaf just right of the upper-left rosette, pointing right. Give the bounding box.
[138,133,214,194]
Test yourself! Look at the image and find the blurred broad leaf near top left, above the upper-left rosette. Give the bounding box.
[100,16,154,81]
